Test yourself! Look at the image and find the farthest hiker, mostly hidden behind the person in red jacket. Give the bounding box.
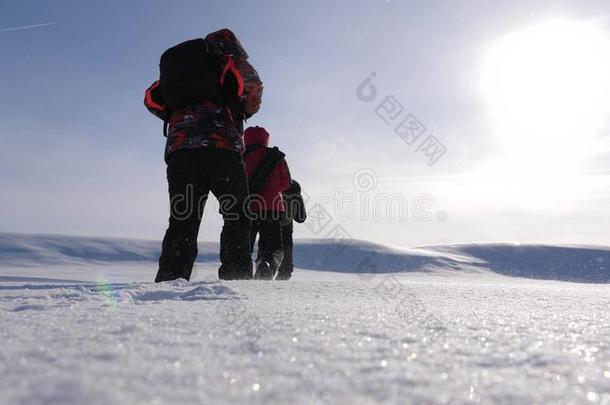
[275,179,307,280]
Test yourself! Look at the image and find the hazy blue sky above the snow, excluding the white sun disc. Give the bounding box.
[0,0,610,246]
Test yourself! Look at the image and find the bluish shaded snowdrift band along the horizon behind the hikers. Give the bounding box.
[0,233,610,283]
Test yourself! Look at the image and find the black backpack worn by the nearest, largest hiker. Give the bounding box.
[159,38,242,113]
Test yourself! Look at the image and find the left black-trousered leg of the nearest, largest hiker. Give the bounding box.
[155,151,208,282]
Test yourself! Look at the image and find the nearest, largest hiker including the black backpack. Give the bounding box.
[145,29,263,282]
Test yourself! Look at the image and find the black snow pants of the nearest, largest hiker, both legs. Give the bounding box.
[155,148,252,282]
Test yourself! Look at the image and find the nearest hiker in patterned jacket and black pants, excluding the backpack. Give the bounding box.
[144,29,263,282]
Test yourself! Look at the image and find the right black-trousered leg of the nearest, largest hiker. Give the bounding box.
[209,149,252,280]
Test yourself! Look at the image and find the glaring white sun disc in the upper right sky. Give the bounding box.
[481,20,610,175]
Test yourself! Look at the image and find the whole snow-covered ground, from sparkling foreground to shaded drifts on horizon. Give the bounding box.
[0,234,610,404]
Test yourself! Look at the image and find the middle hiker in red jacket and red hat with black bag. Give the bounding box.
[244,127,291,280]
